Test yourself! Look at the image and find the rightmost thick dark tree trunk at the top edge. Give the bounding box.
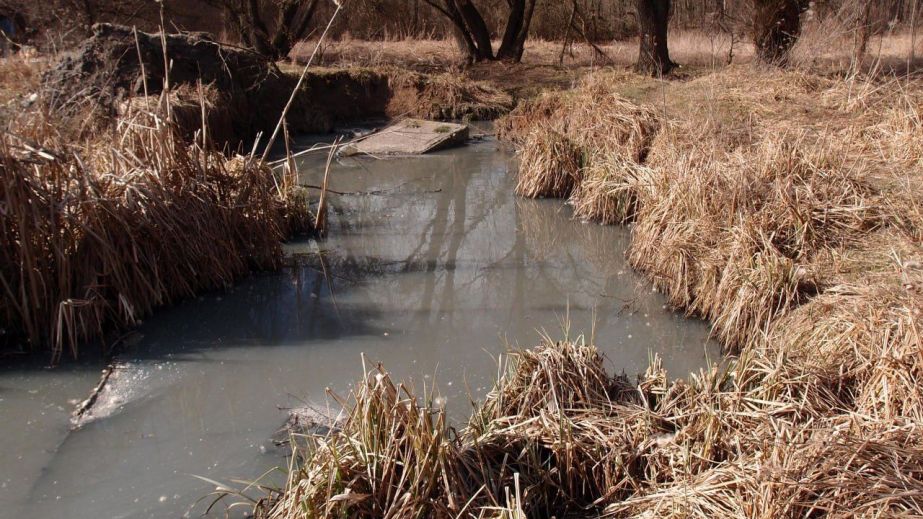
[753,0,806,66]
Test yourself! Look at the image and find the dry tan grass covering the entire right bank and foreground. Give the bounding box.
[262,53,923,519]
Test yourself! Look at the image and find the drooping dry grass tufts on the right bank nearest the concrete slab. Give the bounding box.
[498,80,660,205]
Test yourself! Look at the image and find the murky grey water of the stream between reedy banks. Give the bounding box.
[0,135,718,519]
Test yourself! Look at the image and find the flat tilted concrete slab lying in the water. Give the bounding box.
[341,119,469,156]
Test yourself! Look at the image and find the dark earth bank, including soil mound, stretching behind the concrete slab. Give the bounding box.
[42,24,512,148]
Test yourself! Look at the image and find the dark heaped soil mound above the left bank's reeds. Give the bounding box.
[42,24,282,142]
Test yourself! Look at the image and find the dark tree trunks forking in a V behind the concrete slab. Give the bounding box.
[424,0,537,62]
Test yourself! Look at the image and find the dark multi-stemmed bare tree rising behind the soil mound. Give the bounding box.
[212,0,320,60]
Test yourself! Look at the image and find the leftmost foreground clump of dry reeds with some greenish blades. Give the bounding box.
[257,366,460,518]
